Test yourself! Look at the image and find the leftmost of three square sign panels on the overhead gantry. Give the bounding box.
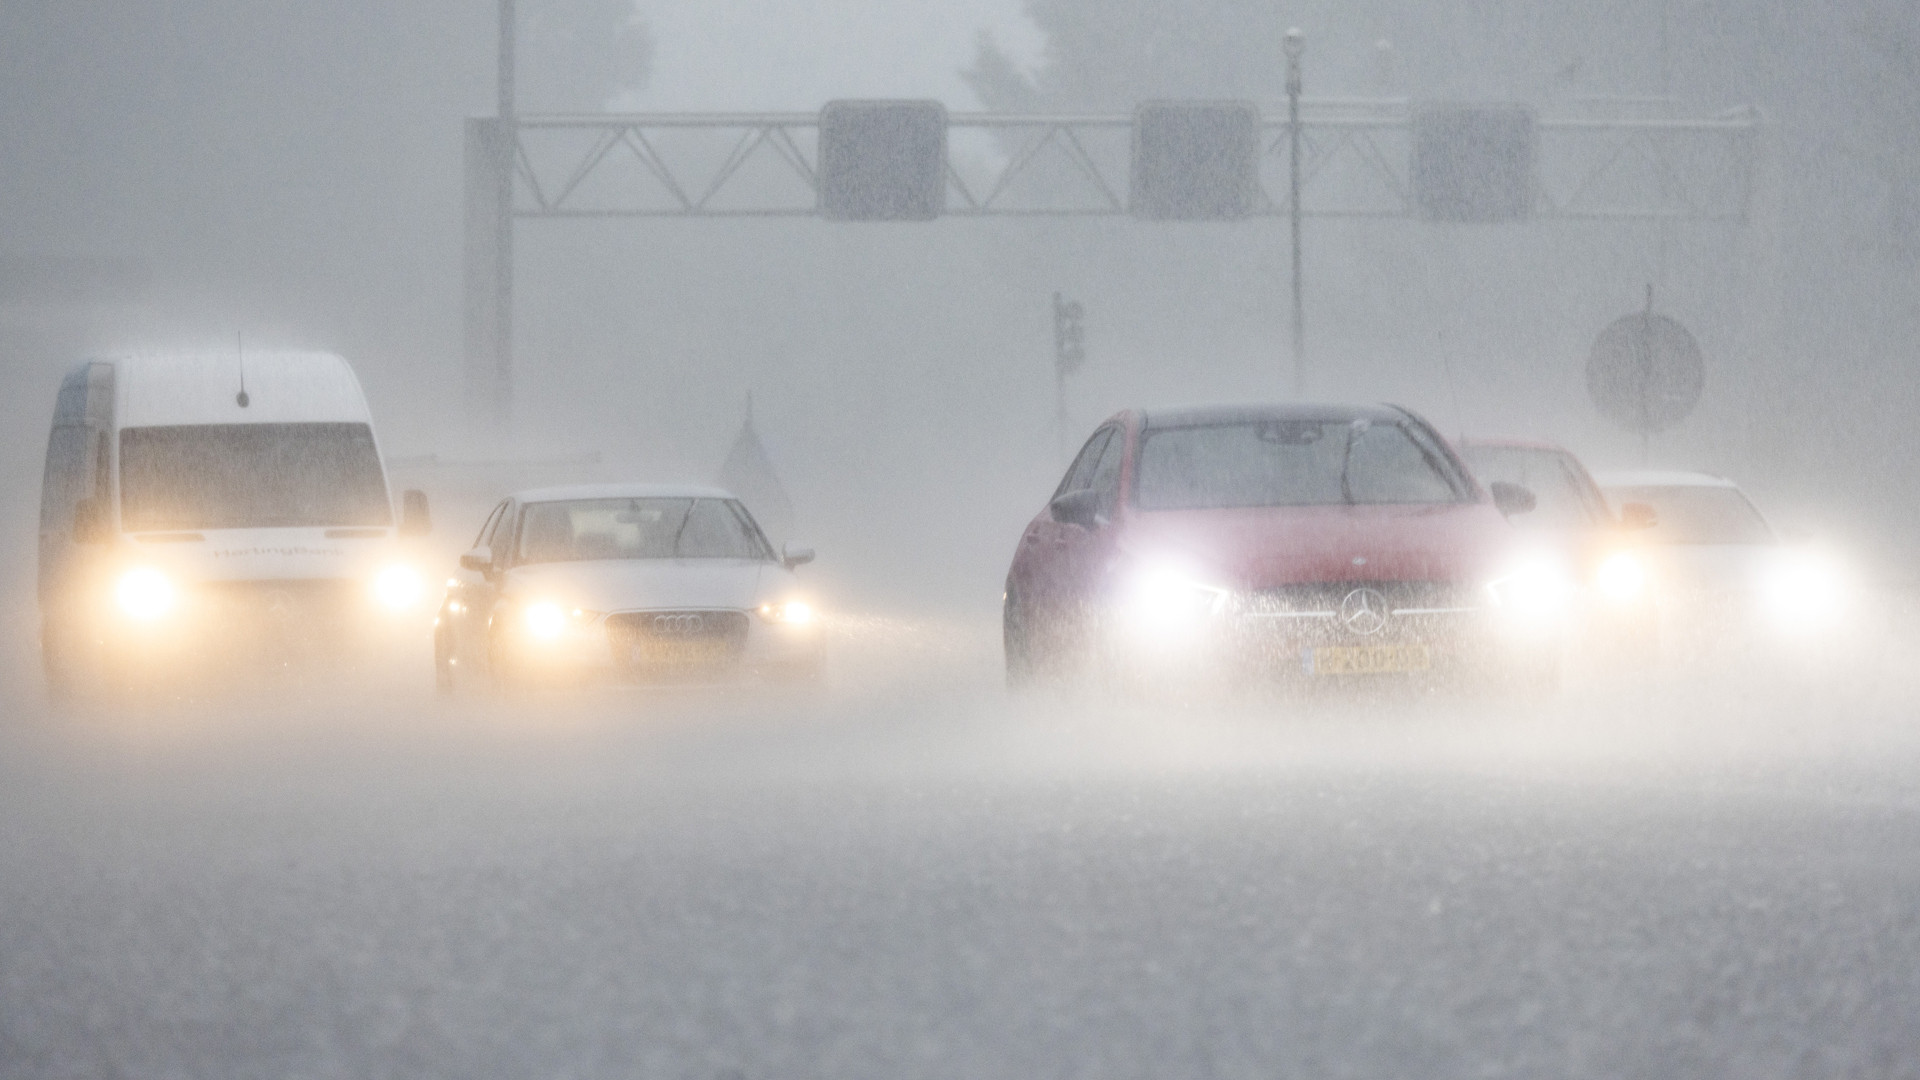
[820,102,947,221]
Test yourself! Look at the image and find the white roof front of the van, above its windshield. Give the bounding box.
[109,350,371,427]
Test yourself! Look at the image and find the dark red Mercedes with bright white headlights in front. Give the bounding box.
[1004,405,1572,684]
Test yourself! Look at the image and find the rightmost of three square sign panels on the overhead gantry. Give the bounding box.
[1411,106,1536,221]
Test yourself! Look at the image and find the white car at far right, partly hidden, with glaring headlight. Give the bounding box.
[1596,471,1853,651]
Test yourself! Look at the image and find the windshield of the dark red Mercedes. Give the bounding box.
[1135,419,1467,509]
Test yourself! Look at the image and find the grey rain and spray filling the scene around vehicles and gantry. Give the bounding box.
[0,0,1920,1078]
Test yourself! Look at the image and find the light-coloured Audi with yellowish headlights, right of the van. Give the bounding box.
[434,484,822,690]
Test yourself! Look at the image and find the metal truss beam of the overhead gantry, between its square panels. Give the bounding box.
[513,100,1763,221]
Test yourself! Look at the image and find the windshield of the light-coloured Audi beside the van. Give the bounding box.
[516,498,774,563]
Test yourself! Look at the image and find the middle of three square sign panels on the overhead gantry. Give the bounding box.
[1129,102,1260,221]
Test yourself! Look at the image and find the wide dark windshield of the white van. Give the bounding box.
[121,423,394,532]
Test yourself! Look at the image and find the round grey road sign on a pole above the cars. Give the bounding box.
[1586,311,1707,434]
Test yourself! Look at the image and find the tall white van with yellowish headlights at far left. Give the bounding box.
[38,352,428,696]
